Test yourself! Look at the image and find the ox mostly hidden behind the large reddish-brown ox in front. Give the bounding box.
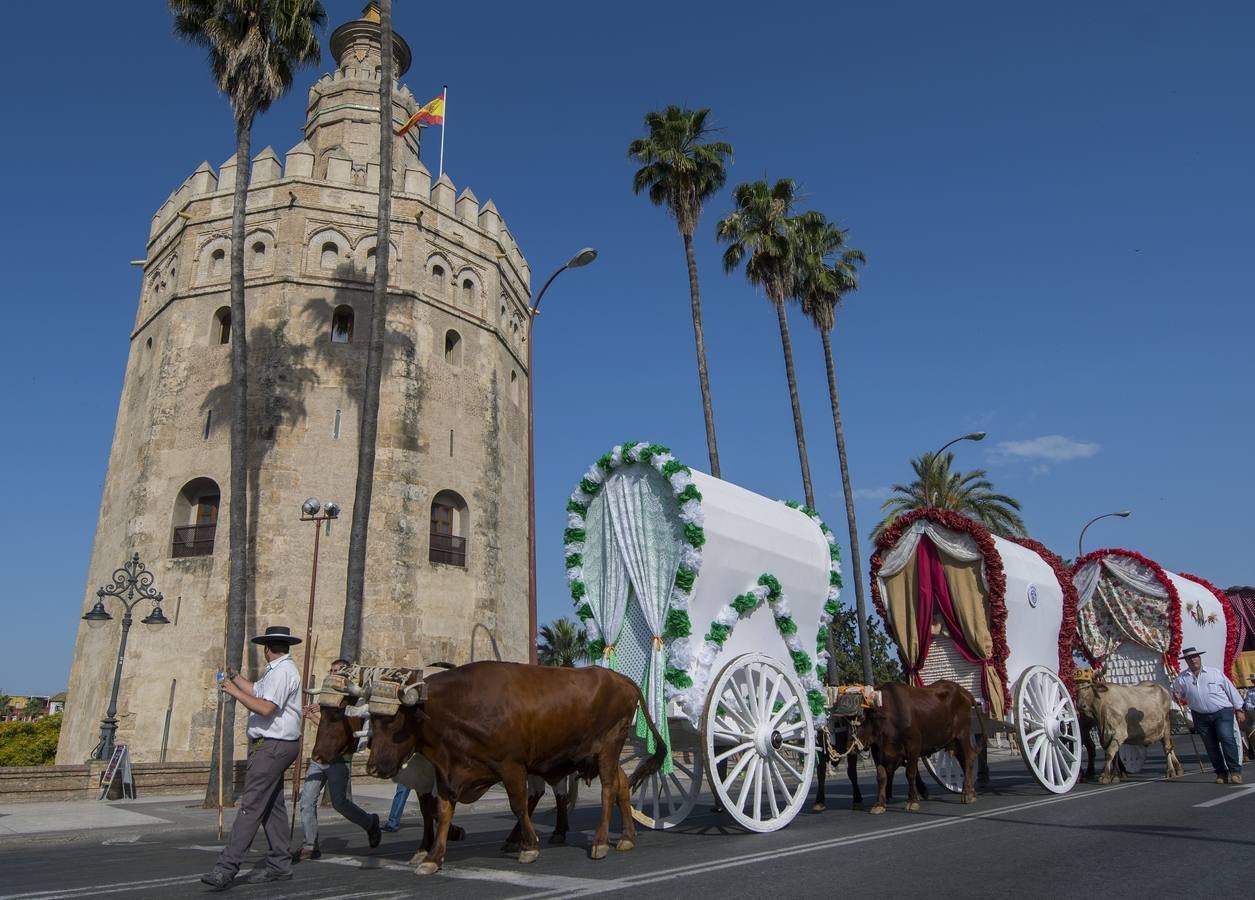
[311,664,579,865]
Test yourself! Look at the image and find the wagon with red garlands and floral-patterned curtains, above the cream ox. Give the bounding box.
[1072,549,1240,772]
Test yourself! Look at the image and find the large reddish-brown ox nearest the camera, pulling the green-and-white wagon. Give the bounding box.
[366,662,666,875]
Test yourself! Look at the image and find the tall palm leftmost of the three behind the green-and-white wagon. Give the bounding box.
[628,105,732,478]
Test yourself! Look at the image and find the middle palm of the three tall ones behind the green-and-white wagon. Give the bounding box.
[715,178,814,510]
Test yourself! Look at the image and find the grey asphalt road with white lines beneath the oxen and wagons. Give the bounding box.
[0,756,1255,900]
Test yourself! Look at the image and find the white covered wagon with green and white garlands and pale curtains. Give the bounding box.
[565,442,841,831]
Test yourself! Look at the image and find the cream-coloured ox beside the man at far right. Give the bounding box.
[1077,682,1185,785]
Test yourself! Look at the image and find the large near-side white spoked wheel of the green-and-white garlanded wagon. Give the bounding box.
[702,653,814,831]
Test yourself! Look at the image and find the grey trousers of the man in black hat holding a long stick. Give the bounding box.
[215,738,296,875]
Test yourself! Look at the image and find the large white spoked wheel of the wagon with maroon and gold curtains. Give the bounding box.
[1015,665,1081,793]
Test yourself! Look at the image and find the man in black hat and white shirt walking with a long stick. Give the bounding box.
[201,625,301,891]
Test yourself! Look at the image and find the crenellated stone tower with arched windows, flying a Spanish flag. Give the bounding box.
[58,8,531,763]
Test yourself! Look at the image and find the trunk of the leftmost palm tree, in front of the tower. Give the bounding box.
[205,113,252,806]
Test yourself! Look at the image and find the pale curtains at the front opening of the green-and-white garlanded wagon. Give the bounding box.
[602,466,681,774]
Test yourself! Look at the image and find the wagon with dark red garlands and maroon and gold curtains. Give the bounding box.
[871,510,1081,793]
